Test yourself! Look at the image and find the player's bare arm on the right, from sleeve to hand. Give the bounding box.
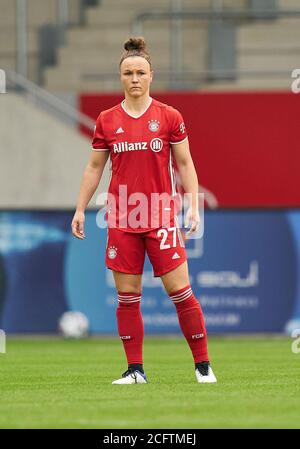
[171,139,200,237]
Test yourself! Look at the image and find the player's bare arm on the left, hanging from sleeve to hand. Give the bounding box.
[71,151,109,240]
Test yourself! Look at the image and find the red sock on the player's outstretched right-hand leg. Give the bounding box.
[170,285,209,363]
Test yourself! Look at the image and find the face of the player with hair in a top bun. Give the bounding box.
[120,56,153,98]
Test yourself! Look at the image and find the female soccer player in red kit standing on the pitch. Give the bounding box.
[72,37,216,384]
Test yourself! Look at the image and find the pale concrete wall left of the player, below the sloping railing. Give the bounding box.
[0,93,109,209]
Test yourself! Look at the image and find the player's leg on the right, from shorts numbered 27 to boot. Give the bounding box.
[146,227,216,382]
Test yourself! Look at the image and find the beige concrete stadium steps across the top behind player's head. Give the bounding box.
[0,0,300,93]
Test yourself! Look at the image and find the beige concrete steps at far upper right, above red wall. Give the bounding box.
[204,18,300,90]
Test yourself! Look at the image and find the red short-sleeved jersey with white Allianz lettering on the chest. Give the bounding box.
[92,98,187,232]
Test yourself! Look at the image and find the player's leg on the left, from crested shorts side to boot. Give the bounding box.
[106,230,147,384]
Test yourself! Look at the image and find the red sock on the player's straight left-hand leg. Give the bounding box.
[116,292,144,365]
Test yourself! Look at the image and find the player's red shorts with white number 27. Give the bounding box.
[105,221,187,277]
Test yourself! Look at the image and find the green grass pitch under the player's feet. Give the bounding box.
[0,336,300,429]
